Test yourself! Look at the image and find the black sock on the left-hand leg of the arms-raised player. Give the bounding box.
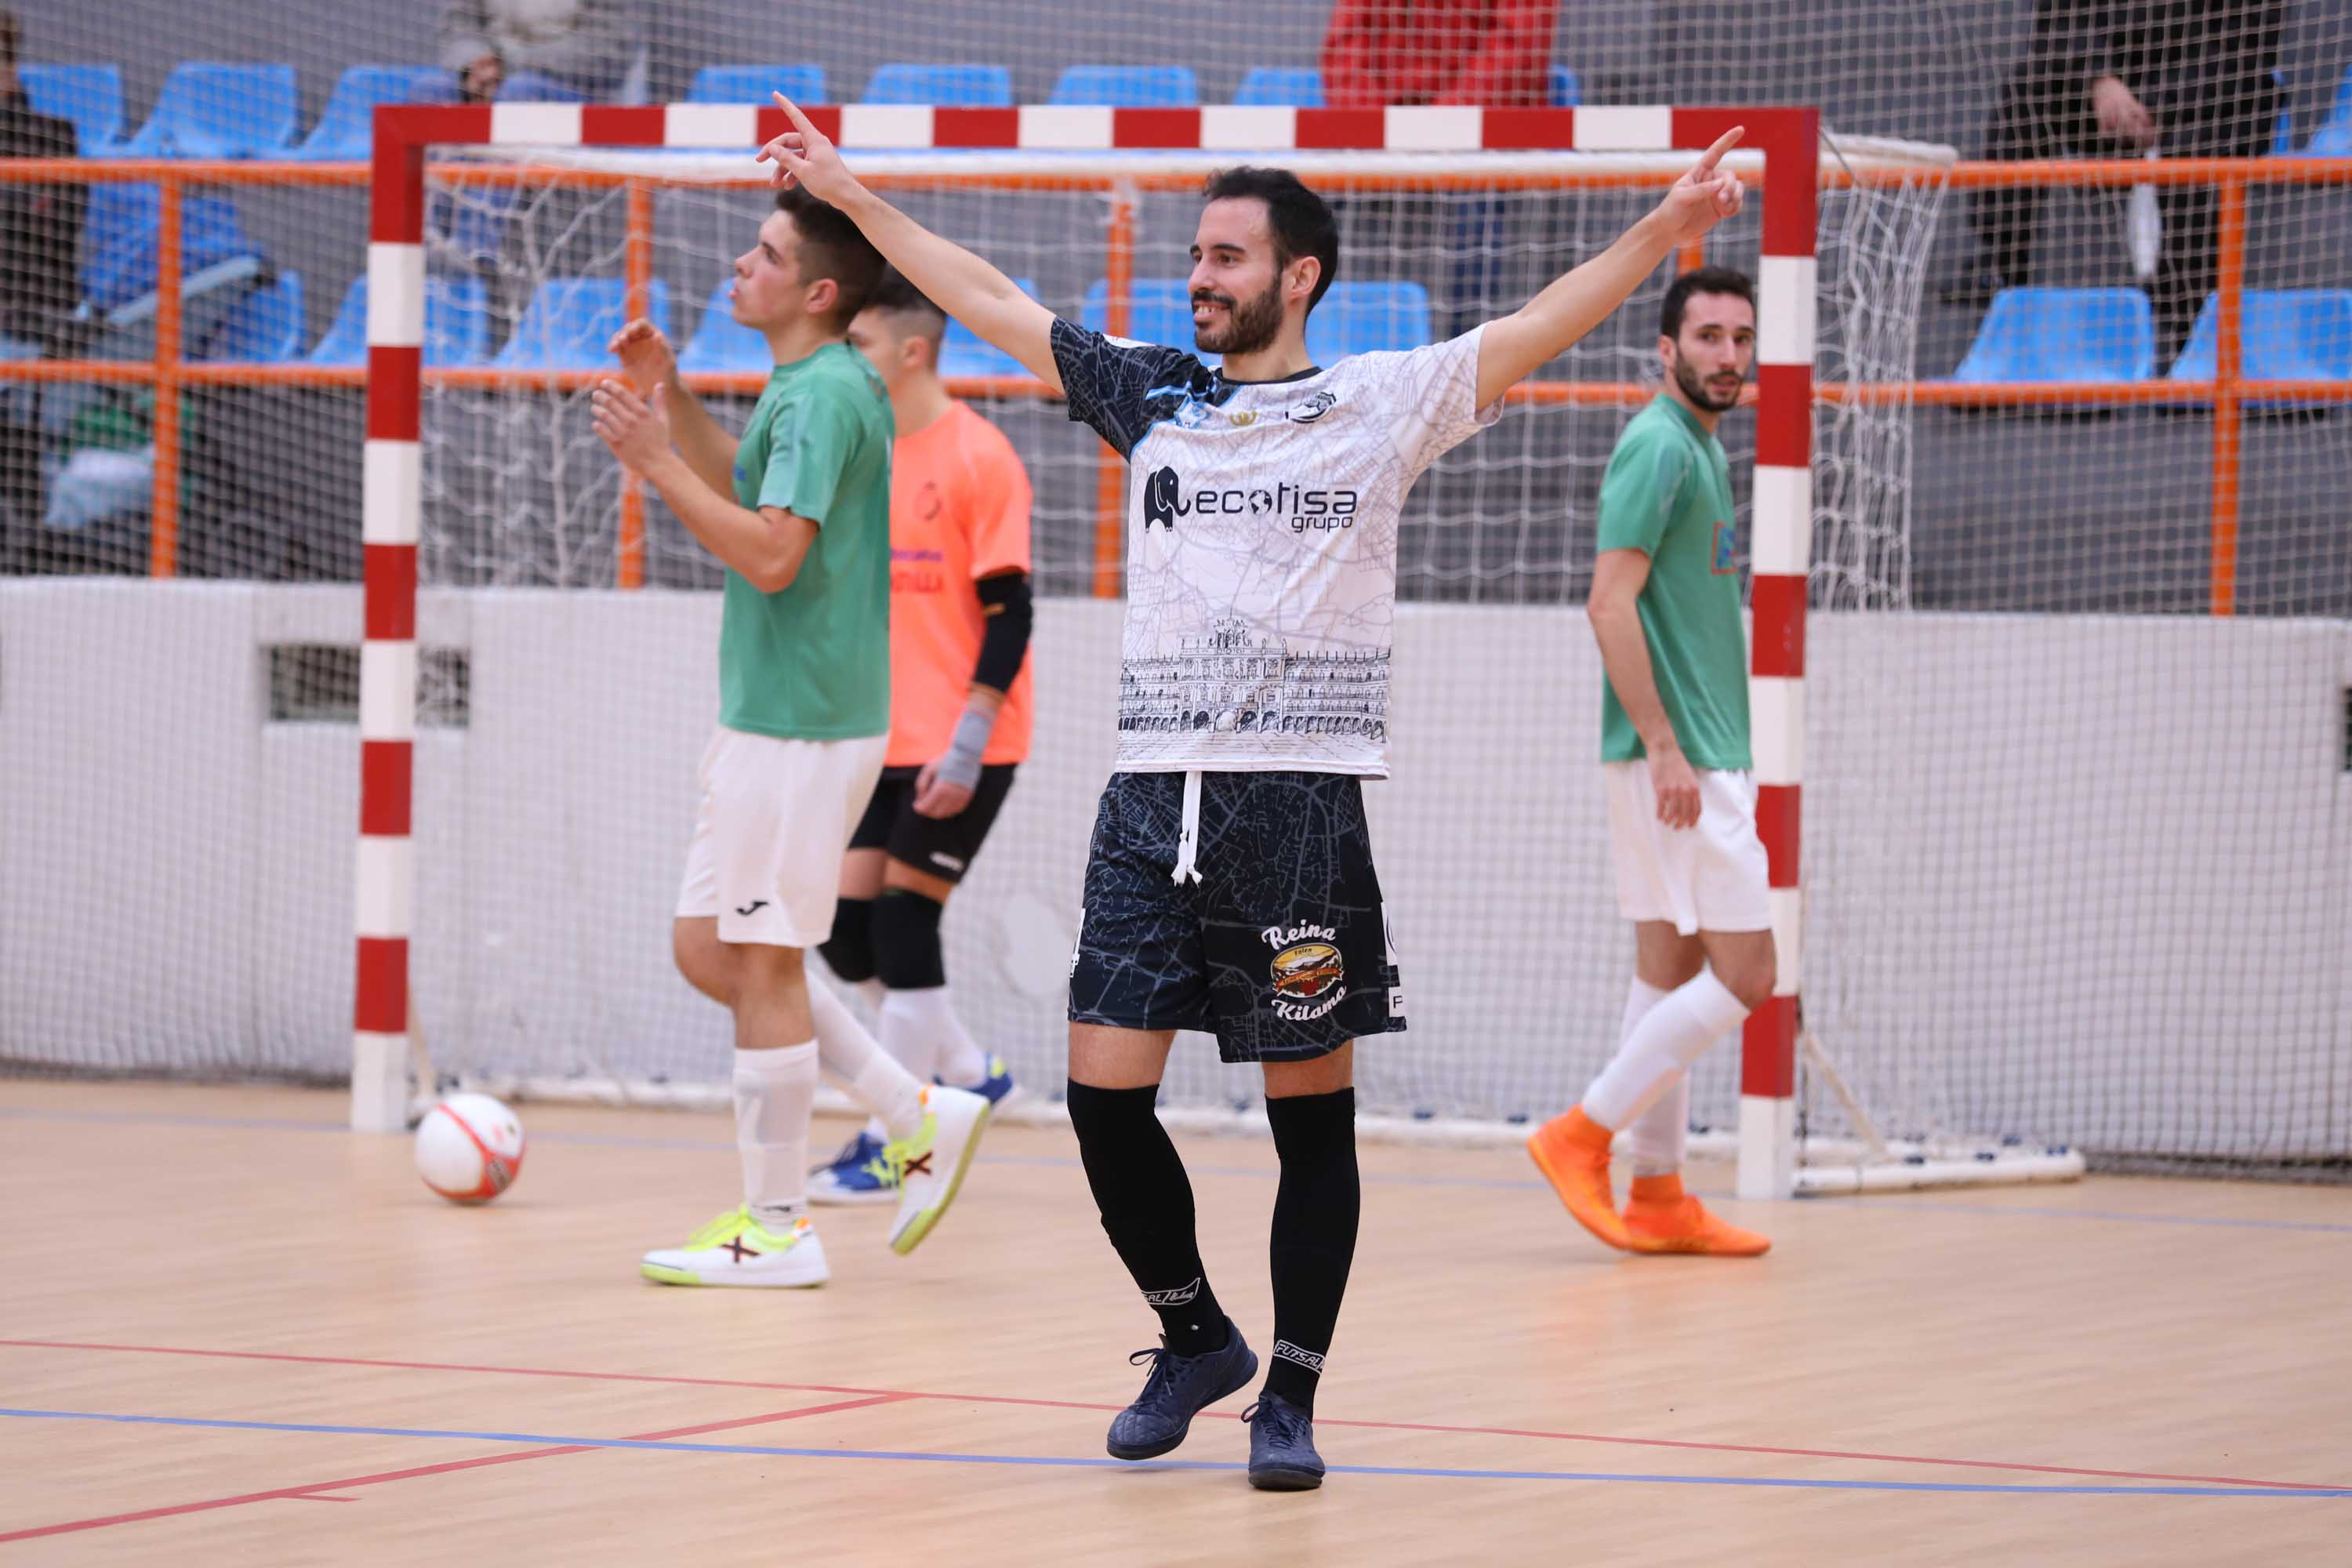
[1070,1081,1223,1356]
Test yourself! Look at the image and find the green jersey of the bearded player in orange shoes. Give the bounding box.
[1599,393,1752,769]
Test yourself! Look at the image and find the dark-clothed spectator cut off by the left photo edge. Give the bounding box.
[0,12,89,552]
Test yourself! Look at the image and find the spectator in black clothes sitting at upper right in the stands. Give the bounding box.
[1955,0,2286,372]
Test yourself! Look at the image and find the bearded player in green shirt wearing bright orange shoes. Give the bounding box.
[1526,266,1776,1258]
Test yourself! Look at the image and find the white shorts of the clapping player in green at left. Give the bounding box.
[677,727,889,947]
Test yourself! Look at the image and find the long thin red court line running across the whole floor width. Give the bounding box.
[0,1340,2340,1495]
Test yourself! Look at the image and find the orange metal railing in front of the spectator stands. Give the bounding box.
[0,158,2352,616]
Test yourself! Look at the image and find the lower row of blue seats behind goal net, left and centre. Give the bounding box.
[195,273,1430,379]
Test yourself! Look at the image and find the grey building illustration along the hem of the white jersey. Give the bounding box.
[1120,619,1388,741]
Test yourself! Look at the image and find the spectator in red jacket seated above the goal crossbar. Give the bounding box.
[1322,0,1559,336]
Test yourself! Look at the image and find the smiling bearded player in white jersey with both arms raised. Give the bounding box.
[760,92,1740,1490]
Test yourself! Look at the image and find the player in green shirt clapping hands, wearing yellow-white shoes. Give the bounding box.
[595,191,988,1286]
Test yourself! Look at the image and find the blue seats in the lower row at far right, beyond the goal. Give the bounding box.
[1952,289,2352,386]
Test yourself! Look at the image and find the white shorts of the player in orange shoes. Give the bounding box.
[1602,757,1771,935]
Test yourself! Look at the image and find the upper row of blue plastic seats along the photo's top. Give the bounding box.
[21,61,1590,160]
